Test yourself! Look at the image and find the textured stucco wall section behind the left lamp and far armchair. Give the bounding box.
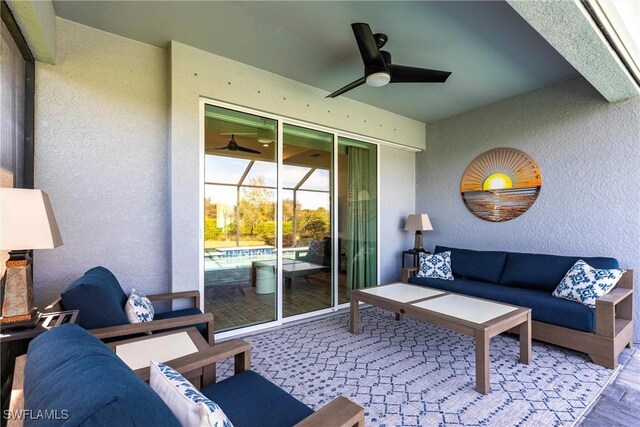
[34,19,170,304]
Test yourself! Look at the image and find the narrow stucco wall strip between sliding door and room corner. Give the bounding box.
[379,146,416,283]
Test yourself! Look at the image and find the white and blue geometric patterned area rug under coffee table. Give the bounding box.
[220,308,614,426]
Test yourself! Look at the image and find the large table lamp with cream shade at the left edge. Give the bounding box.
[0,188,62,326]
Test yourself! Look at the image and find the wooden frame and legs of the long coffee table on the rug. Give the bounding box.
[351,285,531,394]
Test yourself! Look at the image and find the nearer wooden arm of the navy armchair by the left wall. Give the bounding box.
[89,313,214,345]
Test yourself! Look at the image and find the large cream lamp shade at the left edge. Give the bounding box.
[0,188,62,251]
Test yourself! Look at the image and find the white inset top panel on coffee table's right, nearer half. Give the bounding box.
[411,294,518,323]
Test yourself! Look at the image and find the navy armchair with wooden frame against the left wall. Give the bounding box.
[44,267,214,345]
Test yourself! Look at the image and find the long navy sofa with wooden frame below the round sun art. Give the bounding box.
[403,246,633,367]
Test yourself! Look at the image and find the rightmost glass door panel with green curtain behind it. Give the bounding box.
[337,137,378,303]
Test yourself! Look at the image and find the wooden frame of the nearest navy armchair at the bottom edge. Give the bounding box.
[7,339,364,427]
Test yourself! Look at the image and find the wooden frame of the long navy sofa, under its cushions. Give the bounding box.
[402,267,633,369]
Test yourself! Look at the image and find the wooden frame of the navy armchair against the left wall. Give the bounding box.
[44,291,214,345]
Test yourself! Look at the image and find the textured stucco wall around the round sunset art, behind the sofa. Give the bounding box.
[416,78,640,341]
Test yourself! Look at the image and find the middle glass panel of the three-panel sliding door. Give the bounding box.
[281,124,333,317]
